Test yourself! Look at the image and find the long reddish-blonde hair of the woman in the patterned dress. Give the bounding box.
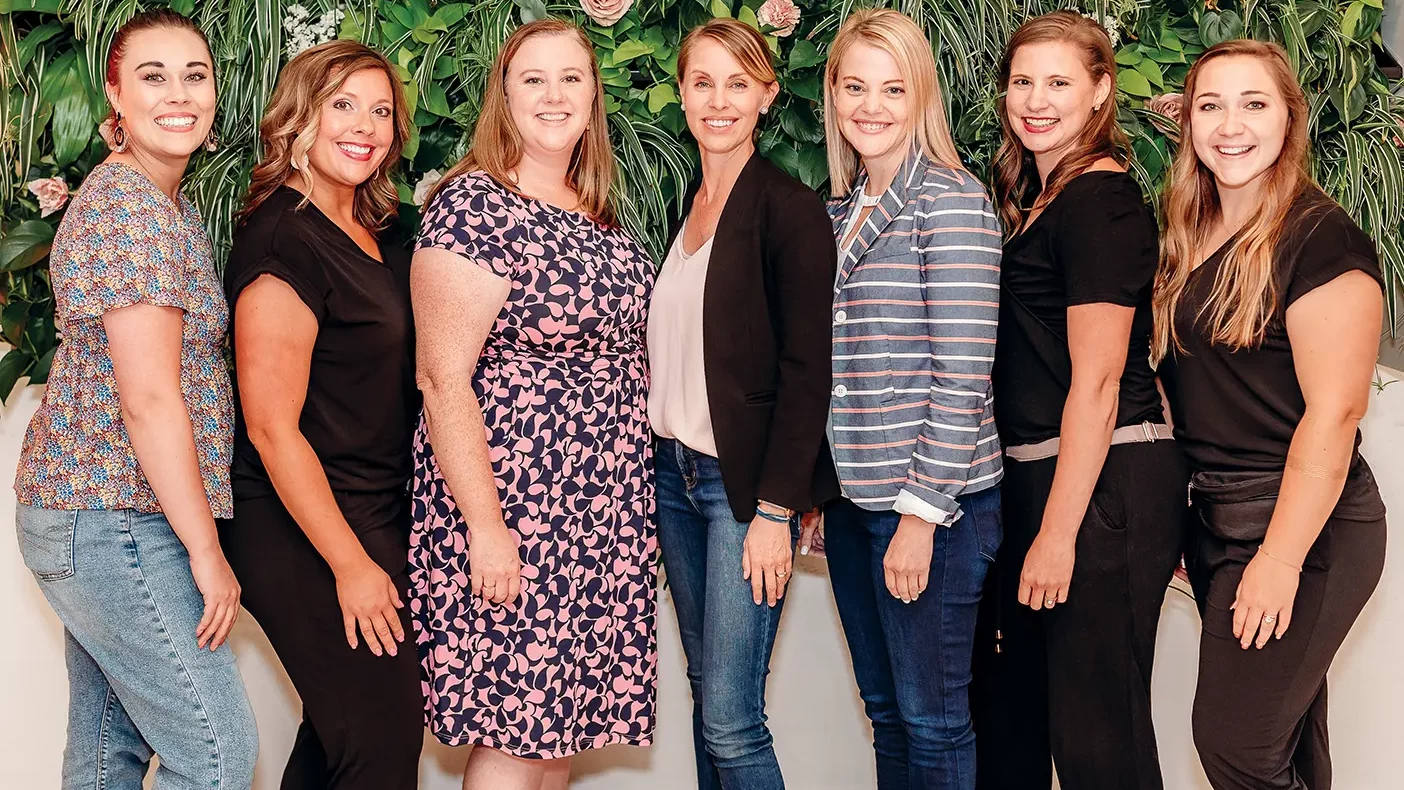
[425,18,615,226]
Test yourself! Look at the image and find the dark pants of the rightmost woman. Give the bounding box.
[1188,505,1386,790]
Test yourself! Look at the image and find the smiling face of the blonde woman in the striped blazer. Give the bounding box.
[834,43,913,170]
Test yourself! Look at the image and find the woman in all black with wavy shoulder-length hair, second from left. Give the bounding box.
[222,41,424,790]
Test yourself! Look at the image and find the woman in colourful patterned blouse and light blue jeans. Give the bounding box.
[12,10,258,790]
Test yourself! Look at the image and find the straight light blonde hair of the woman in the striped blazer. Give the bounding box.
[824,8,965,198]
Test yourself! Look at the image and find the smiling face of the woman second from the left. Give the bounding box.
[307,69,395,188]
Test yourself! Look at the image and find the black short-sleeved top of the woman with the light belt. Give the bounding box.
[994,170,1164,446]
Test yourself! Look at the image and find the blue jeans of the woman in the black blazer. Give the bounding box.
[654,439,799,790]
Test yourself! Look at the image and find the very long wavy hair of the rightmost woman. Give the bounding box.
[1151,39,1314,361]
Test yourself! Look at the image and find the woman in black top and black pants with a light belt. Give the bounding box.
[972,11,1188,790]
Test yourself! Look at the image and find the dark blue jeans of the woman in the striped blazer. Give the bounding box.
[824,487,1002,790]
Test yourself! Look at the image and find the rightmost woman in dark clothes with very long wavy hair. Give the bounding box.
[1154,41,1386,790]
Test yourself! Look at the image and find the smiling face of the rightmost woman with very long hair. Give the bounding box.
[1189,56,1289,189]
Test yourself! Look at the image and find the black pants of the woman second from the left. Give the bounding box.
[220,495,424,790]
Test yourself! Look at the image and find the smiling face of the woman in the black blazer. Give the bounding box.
[681,38,779,153]
